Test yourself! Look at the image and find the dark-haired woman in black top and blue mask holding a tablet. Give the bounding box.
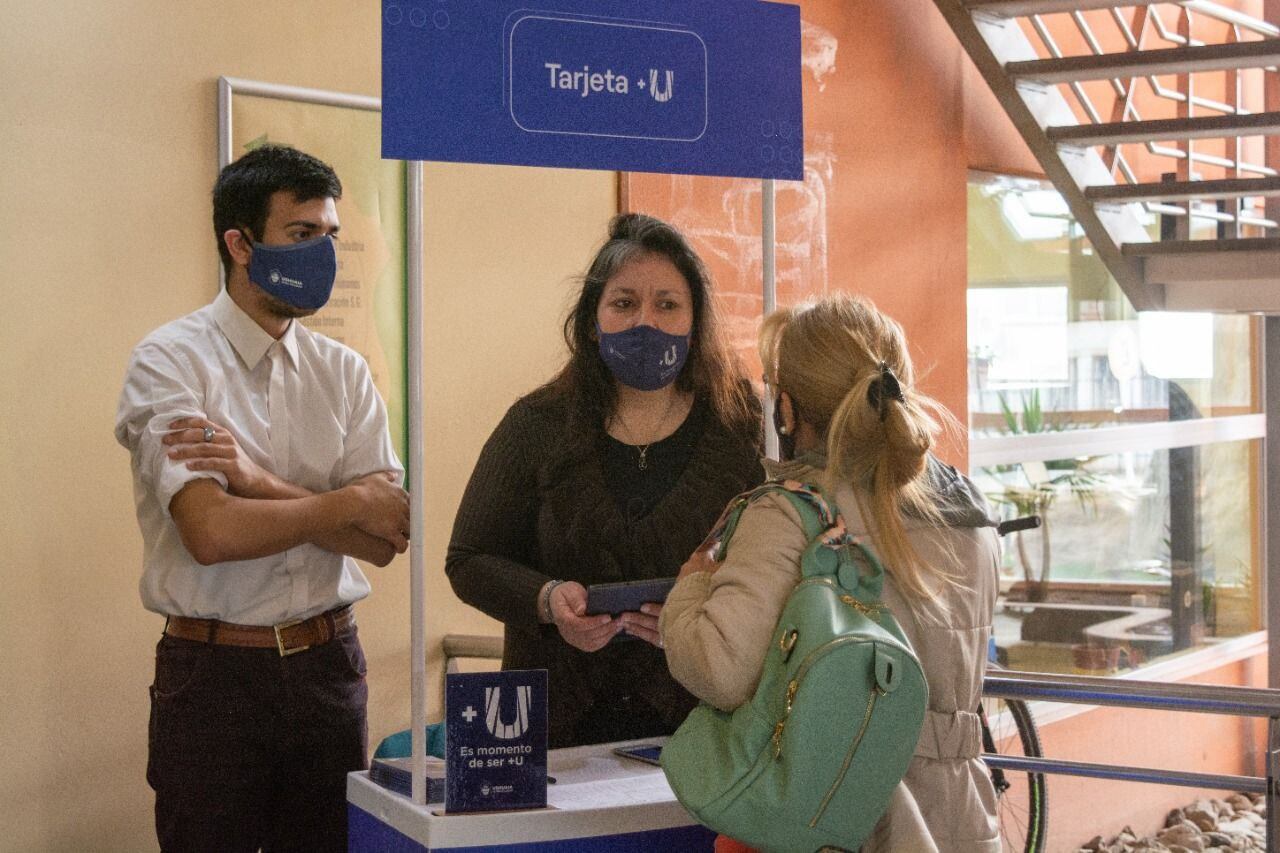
[445,214,762,748]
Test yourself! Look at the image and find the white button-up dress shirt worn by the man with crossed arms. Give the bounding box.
[115,291,404,625]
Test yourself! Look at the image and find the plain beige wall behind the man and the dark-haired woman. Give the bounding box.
[0,0,616,852]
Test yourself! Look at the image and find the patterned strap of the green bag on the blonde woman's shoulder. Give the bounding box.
[707,480,884,602]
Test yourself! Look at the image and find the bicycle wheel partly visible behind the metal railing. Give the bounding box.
[980,697,1048,853]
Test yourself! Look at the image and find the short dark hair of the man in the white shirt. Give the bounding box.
[214,145,342,270]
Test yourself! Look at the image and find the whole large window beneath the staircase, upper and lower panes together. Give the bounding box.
[969,175,1263,674]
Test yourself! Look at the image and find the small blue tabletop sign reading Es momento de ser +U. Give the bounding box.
[444,670,547,812]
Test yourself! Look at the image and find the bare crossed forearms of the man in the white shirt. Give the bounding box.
[164,418,408,566]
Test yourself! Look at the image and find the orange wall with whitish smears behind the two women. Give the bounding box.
[623,0,968,464]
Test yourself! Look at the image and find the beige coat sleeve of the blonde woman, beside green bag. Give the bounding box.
[659,494,806,711]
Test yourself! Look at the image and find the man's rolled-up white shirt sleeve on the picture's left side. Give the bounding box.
[115,343,227,516]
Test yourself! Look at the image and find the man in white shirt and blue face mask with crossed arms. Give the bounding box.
[115,146,408,850]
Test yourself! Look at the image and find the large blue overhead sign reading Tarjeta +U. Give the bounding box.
[383,0,804,179]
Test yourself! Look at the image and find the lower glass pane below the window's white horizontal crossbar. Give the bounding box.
[974,442,1260,675]
